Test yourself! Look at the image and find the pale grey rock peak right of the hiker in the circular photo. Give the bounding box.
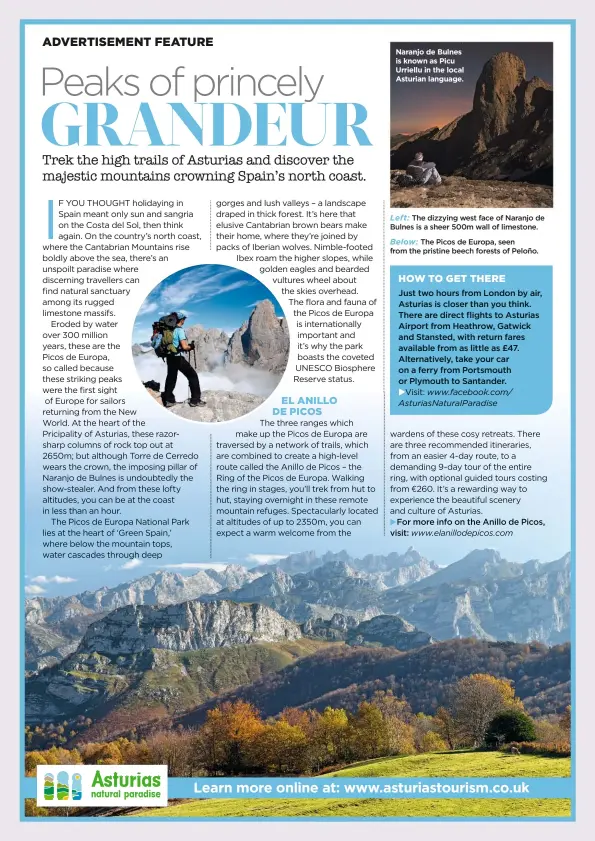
[225,300,289,374]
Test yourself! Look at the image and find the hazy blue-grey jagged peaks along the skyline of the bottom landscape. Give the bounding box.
[25,548,570,671]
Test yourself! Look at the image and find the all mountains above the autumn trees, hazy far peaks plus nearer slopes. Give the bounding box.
[26,549,570,739]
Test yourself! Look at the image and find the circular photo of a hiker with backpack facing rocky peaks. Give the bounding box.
[132,265,289,423]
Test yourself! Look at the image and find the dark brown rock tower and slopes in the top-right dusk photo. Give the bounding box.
[391,52,553,184]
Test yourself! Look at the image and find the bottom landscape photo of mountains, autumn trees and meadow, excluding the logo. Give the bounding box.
[24,548,571,820]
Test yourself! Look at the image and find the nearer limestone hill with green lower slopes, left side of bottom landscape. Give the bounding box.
[25,601,302,720]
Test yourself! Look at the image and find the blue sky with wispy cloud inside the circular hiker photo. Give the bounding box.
[132,264,283,342]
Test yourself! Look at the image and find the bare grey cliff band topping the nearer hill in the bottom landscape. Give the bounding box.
[80,601,301,657]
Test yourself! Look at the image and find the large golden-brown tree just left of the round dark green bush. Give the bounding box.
[452,674,522,747]
